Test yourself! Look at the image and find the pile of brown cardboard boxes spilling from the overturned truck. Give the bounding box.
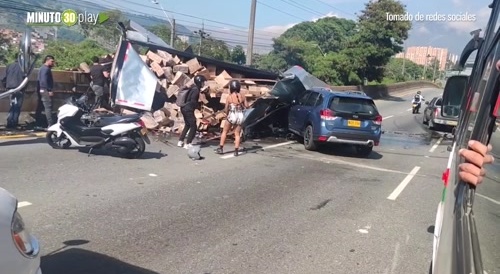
[132,51,274,135]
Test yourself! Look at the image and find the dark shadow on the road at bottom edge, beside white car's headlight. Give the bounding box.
[41,240,159,274]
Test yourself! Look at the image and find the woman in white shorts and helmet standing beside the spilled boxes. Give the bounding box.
[216,80,248,156]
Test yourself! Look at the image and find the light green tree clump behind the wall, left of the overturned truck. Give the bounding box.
[37,39,109,70]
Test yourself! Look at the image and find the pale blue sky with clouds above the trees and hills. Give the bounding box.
[101,0,491,54]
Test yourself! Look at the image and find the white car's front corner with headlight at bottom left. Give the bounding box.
[0,188,42,274]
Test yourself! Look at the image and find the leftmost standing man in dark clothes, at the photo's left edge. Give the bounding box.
[2,53,25,128]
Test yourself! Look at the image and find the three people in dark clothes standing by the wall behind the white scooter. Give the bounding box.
[2,54,109,129]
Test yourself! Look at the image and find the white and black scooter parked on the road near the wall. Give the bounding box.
[46,98,150,159]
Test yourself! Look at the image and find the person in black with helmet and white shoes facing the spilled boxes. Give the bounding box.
[177,75,207,149]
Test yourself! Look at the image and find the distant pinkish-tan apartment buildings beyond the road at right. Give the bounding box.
[395,47,452,70]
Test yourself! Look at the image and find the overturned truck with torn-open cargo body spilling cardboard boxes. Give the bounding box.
[110,21,328,138]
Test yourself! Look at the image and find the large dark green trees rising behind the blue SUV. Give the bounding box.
[255,0,411,85]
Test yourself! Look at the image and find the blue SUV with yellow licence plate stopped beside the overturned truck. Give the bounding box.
[288,88,382,157]
